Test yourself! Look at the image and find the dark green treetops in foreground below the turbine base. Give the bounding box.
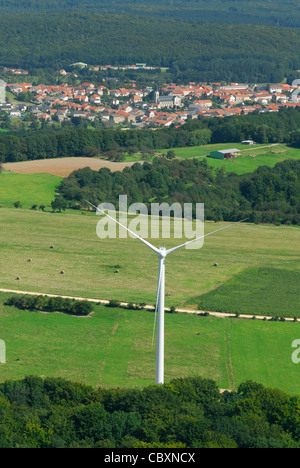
[0,376,300,449]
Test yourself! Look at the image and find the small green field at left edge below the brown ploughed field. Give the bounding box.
[0,172,62,208]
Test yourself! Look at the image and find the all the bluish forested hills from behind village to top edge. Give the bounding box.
[0,0,300,83]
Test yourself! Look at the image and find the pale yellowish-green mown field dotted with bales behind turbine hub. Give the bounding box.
[0,208,300,307]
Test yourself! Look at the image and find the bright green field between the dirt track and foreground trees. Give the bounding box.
[0,294,300,394]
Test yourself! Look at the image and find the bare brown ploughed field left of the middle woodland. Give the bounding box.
[3,158,140,177]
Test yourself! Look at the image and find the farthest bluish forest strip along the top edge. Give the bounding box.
[0,0,300,27]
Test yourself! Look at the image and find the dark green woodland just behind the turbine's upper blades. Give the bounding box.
[57,158,300,225]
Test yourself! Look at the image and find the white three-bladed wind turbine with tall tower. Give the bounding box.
[86,200,248,385]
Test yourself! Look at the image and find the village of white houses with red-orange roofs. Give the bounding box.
[0,64,300,129]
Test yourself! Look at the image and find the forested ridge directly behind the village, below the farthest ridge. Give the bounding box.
[0,10,300,83]
